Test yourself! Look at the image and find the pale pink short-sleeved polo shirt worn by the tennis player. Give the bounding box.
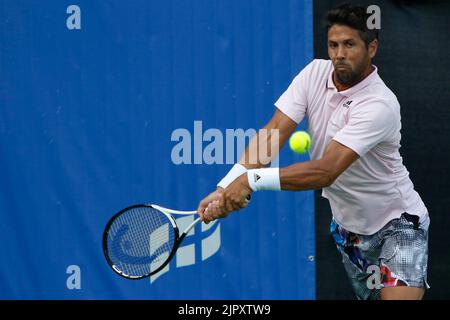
[275,59,427,235]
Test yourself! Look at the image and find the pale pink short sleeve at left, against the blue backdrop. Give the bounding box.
[275,60,315,123]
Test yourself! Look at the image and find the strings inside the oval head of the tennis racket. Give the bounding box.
[107,207,175,276]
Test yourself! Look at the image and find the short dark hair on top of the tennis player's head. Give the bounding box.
[325,3,378,47]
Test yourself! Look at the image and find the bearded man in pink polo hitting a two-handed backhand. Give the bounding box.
[198,5,429,299]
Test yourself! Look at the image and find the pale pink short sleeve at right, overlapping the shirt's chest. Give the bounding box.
[333,102,398,157]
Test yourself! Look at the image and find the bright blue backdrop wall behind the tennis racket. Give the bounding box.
[0,0,315,299]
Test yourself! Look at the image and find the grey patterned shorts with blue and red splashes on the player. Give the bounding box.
[330,213,430,300]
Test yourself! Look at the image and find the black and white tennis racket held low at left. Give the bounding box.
[103,204,201,279]
